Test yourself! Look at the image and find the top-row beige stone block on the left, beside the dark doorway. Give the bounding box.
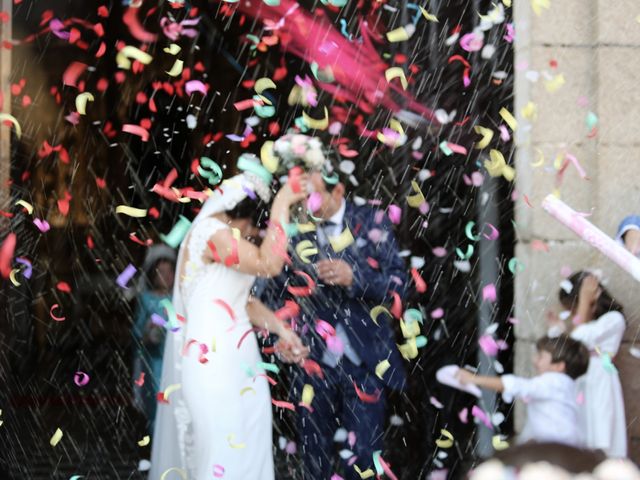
[528,0,597,45]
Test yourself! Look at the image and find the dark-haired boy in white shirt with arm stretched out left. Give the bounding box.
[456,335,589,447]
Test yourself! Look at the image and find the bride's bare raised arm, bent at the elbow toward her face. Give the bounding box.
[207,179,306,277]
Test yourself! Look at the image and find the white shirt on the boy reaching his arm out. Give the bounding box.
[501,372,584,447]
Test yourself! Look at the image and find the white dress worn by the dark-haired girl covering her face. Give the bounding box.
[571,311,627,457]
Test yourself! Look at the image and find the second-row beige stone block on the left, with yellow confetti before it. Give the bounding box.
[528,46,596,145]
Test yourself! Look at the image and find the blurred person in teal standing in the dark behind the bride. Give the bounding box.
[133,245,176,433]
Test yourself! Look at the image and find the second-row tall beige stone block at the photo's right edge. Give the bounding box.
[591,47,640,145]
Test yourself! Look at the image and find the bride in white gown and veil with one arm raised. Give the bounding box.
[149,159,308,480]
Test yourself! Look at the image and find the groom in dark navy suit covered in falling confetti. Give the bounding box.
[263,172,405,480]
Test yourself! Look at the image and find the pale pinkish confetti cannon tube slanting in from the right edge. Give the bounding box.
[542,195,640,281]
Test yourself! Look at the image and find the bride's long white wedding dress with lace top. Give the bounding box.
[149,217,274,480]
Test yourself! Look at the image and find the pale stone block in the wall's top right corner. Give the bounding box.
[594,0,640,46]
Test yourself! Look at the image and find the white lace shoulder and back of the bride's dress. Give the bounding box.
[179,217,229,305]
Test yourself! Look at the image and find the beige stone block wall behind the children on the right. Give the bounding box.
[513,0,640,461]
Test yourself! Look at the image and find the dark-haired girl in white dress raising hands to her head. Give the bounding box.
[549,271,627,457]
